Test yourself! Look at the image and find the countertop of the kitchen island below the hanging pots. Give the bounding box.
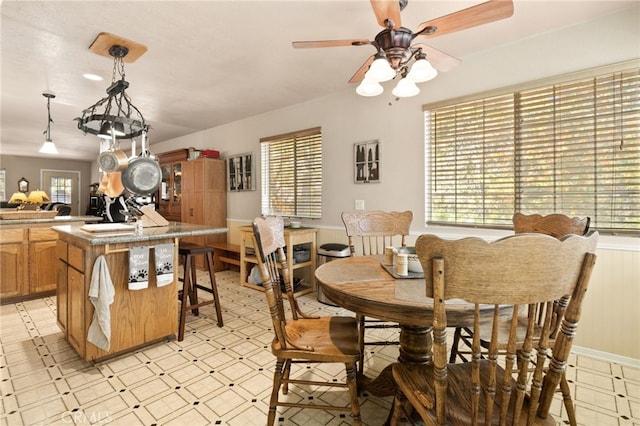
[51,222,228,245]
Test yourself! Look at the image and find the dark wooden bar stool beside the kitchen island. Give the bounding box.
[178,241,223,342]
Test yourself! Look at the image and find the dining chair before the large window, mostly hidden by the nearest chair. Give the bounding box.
[449,213,591,426]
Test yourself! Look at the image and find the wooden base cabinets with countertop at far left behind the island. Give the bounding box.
[0,213,102,304]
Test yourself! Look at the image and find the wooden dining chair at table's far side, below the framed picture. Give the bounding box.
[342,211,413,374]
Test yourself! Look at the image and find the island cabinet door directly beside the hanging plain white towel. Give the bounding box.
[67,267,89,358]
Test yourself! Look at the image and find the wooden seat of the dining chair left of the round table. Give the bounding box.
[272,316,360,362]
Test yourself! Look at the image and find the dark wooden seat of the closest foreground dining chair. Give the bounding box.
[393,360,556,426]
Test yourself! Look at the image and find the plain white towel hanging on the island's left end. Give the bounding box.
[87,256,115,351]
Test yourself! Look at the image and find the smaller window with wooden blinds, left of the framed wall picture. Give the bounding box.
[260,127,322,218]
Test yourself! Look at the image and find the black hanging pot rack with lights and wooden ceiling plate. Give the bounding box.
[75,33,149,139]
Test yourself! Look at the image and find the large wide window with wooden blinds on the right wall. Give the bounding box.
[424,64,640,232]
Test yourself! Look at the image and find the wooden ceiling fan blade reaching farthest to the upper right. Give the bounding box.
[416,0,513,38]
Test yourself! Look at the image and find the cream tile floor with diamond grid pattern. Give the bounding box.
[0,271,640,426]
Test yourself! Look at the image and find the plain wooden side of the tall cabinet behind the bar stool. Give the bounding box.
[181,158,227,268]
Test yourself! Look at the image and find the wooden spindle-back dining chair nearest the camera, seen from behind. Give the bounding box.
[391,232,598,425]
